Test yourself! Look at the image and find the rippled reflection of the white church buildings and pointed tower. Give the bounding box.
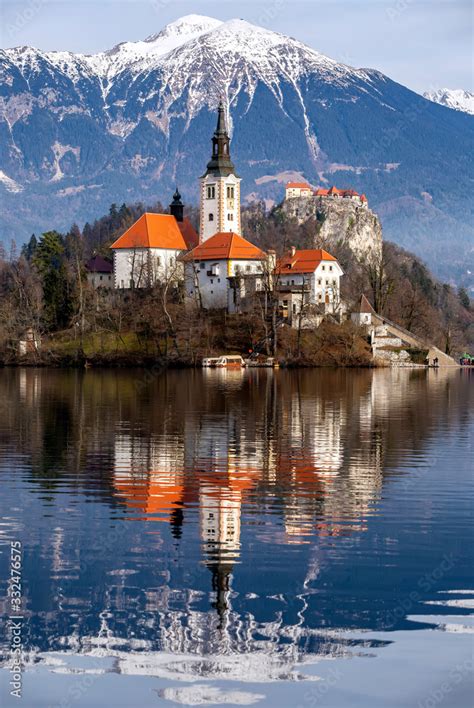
[114,371,382,620]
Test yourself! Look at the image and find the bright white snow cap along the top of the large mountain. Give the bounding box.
[1,15,367,94]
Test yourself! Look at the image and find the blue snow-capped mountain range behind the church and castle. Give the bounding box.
[0,15,474,284]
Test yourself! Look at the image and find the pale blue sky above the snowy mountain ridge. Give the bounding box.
[0,0,474,92]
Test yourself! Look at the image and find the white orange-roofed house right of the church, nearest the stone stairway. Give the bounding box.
[276,243,343,322]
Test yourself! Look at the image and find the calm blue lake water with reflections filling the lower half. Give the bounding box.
[0,369,474,708]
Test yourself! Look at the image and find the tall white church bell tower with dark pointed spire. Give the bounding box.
[199,101,240,243]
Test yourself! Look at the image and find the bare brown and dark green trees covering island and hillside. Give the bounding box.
[0,203,474,365]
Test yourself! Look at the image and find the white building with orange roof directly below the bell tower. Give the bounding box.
[182,232,267,313]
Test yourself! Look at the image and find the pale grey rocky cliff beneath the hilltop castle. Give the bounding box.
[282,197,382,261]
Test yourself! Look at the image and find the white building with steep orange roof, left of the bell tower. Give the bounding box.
[111,212,197,288]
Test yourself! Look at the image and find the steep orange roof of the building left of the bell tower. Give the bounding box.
[111,212,188,251]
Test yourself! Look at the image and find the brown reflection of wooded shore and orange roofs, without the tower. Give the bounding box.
[0,369,470,540]
